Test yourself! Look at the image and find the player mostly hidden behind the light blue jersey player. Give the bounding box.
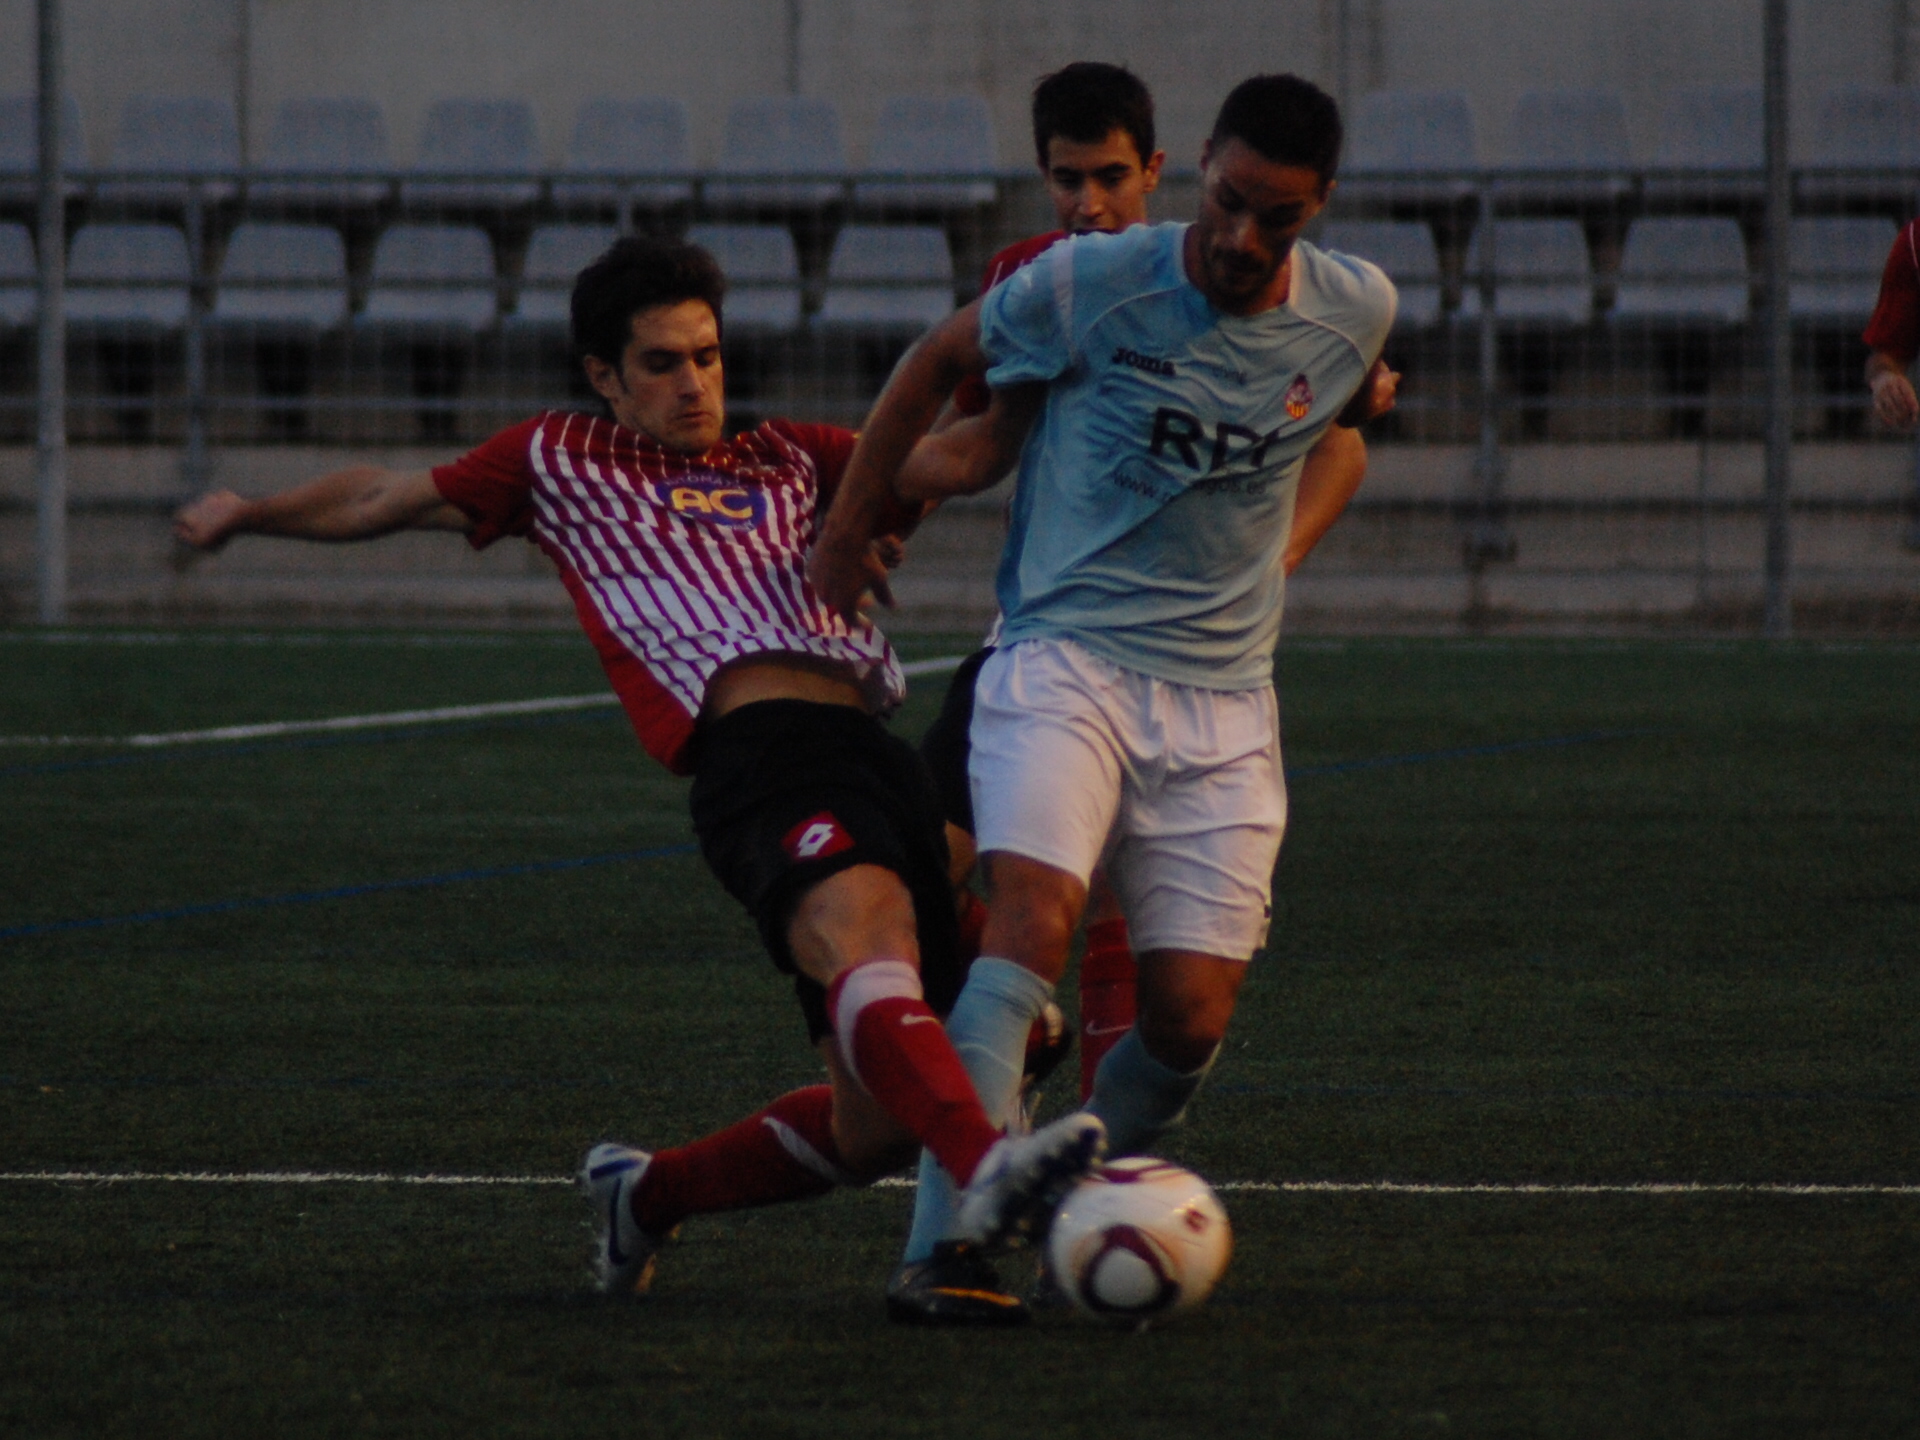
[906,60,1167,1136]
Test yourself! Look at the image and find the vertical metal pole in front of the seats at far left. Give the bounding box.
[33,0,67,626]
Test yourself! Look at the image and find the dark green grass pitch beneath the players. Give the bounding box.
[0,632,1920,1440]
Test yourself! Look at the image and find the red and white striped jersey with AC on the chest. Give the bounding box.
[434,411,906,772]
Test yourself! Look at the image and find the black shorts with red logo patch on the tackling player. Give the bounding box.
[689,701,966,1041]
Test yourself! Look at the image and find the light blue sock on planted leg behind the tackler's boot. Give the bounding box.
[906,956,1054,1263]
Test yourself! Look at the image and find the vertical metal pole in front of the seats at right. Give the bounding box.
[1764,0,1793,639]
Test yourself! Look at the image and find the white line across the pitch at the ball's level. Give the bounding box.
[0,1169,1920,1198]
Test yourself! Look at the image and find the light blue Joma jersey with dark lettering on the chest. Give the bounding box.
[979,225,1394,689]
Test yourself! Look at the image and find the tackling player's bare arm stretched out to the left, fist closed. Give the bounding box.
[173,465,472,549]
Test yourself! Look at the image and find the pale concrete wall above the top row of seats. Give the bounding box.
[0,0,1920,165]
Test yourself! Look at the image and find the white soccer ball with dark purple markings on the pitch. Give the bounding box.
[1046,1156,1233,1325]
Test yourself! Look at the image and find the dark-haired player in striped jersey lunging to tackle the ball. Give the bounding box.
[175,238,1100,1294]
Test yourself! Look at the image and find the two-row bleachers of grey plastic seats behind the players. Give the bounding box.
[0,88,1920,625]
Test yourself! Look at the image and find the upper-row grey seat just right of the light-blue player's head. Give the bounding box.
[1340,90,1478,207]
